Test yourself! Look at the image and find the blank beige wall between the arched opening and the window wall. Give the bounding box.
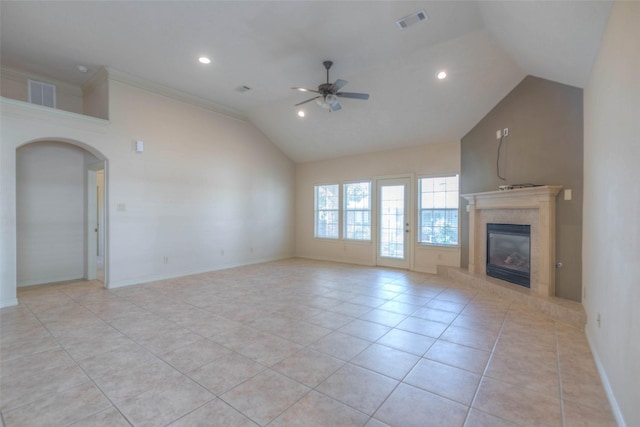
[108,81,294,284]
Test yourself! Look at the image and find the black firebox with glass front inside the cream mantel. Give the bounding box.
[486,223,531,288]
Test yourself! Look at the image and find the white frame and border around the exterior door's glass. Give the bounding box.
[372,174,415,270]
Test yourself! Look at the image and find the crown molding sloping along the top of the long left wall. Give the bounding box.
[104,67,249,122]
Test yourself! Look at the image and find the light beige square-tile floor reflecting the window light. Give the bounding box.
[0,259,616,427]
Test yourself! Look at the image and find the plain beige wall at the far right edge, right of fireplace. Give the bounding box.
[582,2,640,427]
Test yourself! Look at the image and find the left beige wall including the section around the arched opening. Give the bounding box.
[0,74,295,306]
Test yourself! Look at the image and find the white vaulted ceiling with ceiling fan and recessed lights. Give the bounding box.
[0,0,611,162]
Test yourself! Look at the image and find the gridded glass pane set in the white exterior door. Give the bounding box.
[380,185,405,259]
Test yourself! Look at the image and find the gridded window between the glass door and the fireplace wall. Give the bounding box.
[418,175,458,246]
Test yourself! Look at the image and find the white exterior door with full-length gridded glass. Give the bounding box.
[376,178,413,269]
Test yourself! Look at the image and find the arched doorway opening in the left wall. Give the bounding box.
[16,138,108,287]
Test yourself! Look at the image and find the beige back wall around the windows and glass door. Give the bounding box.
[295,142,460,273]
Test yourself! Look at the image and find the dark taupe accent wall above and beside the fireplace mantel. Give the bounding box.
[460,76,583,301]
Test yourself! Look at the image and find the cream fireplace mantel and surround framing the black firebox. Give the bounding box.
[462,185,562,296]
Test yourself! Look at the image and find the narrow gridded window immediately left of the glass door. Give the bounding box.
[343,181,371,241]
